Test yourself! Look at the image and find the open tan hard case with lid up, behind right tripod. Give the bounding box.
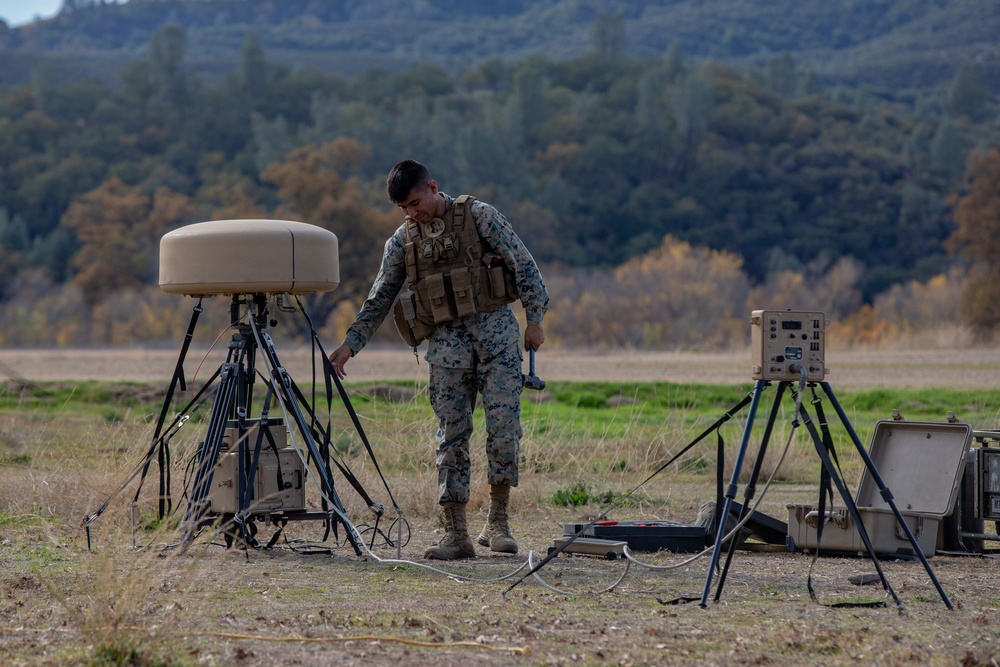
[788,421,972,558]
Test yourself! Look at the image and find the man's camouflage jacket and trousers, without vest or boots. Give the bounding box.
[344,195,549,503]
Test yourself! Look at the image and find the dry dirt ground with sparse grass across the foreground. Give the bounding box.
[0,496,1000,667]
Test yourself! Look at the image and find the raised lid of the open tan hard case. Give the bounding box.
[856,420,972,517]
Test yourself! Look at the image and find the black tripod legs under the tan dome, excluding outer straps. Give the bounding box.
[181,294,361,556]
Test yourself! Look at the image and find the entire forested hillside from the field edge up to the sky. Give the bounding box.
[0,0,1000,347]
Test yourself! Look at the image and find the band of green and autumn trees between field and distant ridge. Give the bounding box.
[0,16,997,348]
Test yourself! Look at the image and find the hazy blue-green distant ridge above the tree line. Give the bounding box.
[0,0,1000,94]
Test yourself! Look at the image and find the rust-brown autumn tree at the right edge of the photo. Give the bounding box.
[949,148,1000,335]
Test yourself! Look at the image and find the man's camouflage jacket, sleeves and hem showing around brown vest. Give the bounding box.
[344,195,549,368]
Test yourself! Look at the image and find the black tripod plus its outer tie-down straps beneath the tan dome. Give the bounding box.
[82,294,390,556]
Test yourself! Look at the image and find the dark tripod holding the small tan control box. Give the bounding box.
[700,380,954,609]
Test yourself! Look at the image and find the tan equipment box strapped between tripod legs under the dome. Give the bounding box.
[208,426,306,514]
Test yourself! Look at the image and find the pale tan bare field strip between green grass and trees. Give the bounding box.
[0,343,1000,390]
